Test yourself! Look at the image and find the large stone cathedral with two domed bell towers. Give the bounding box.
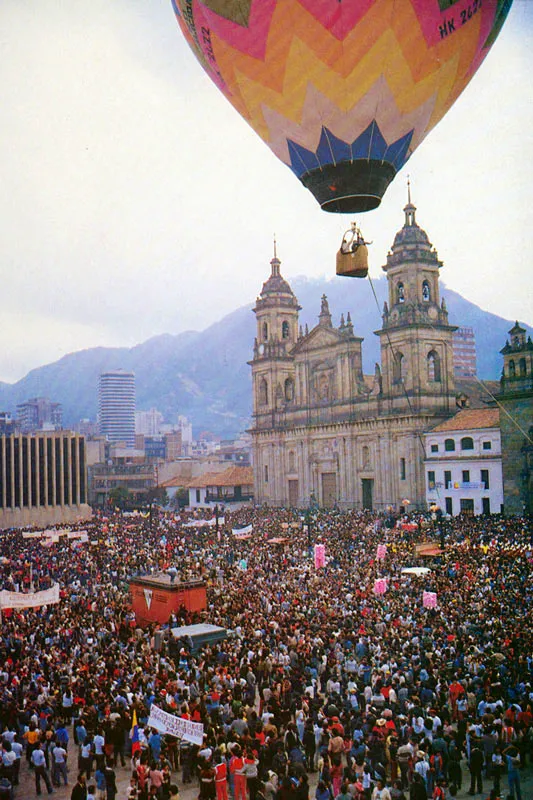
[250,196,474,510]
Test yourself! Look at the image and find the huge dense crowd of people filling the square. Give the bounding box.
[0,508,533,800]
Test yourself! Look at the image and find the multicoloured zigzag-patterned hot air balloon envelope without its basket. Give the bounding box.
[173,0,512,213]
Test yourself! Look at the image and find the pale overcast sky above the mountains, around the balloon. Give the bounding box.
[0,0,533,381]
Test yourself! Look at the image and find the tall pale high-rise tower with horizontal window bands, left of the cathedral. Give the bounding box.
[98,370,135,447]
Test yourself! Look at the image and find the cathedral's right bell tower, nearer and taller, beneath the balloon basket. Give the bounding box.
[376,184,457,414]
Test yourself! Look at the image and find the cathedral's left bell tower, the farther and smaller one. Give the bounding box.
[249,247,300,428]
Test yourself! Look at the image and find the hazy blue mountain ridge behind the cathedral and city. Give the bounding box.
[0,277,533,437]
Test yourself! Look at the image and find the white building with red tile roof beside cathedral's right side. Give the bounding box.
[424,406,503,516]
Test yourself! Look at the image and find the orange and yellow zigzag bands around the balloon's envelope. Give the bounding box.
[212,0,479,150]
